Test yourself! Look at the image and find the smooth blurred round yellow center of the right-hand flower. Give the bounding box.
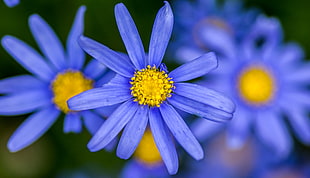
[238,66,275,105]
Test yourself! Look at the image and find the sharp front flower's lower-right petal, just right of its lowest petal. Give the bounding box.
[159,104,203,160]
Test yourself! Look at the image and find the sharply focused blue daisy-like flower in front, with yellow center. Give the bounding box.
[68,2,234,174]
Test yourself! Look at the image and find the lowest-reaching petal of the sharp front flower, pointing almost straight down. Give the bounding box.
[149,108,179,174]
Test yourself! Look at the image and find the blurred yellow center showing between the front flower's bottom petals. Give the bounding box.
[134,129,162,166]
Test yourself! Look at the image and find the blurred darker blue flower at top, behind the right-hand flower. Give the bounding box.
[169,0,258,62]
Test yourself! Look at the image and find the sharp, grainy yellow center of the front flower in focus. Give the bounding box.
[130,65,174,107]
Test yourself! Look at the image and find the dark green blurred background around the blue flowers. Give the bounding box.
[0,0,310,177]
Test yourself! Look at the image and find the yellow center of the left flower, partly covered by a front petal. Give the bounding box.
[51,70,94,113]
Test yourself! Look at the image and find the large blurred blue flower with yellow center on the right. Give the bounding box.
[196,16,310,158]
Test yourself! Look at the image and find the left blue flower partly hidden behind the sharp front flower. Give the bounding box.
[0,6,113,152]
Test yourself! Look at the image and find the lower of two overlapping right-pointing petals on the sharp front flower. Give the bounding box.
[168,94,233,122]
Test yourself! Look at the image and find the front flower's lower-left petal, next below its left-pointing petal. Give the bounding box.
[87,101,138,152]
